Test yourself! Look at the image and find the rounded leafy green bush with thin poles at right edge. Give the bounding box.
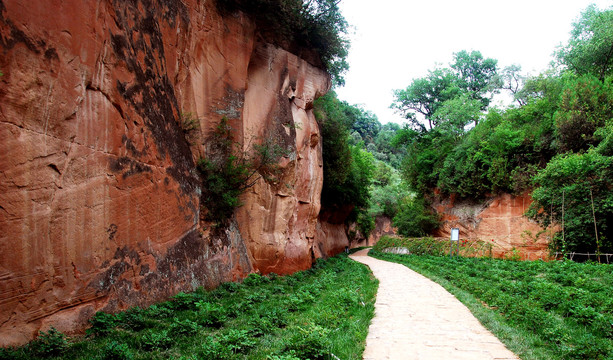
[528,150,613,253]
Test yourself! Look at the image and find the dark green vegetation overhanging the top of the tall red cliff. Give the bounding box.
[216,0,349,85]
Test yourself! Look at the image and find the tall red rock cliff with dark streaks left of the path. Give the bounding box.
[0,0,346,346]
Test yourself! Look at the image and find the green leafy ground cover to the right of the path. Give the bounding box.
[370,251,613,360]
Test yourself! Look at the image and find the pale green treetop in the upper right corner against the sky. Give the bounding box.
[556,5,613,81]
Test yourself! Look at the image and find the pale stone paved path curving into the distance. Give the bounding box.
[351,249,519,360]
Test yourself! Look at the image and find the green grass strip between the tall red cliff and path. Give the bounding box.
[0,254,378,360]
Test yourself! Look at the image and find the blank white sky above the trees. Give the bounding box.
[336,0,613,124]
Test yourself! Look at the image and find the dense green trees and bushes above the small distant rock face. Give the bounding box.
[392,6,613,253]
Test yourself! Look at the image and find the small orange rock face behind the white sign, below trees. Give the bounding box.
[434,194,551,260]
